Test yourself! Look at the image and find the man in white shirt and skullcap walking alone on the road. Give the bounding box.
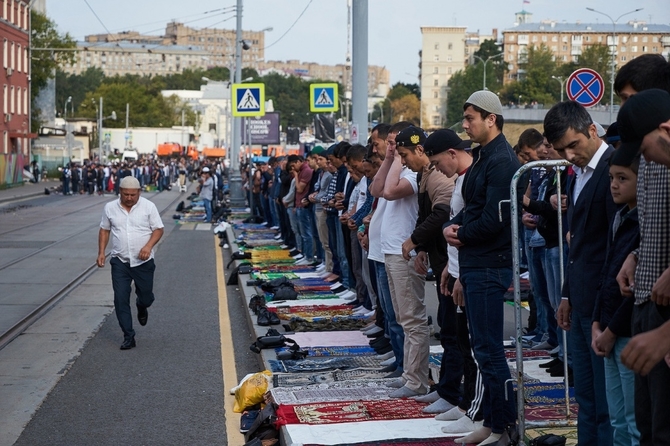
[97,176,163,350]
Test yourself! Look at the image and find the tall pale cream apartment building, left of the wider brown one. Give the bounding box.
[419,26,467,130]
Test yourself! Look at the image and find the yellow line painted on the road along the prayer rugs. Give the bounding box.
[214,237,245,445]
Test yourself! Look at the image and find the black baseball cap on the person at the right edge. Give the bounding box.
[612,88,670,166]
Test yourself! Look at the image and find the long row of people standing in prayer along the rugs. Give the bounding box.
[249,55,670,445]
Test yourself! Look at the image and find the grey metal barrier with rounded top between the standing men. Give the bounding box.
[510,160,575,446]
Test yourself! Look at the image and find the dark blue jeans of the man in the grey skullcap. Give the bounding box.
[460,267,520,434]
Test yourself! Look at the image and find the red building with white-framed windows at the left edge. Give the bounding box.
[0,0,30,155]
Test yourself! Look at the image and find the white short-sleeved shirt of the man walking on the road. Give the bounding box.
[100,197,163,268]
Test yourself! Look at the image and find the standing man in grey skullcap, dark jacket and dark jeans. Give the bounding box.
[443,90,523,445]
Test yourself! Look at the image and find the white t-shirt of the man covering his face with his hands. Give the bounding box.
[381,167,419,255]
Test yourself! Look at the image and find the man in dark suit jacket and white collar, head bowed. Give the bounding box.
[544,101,616,446]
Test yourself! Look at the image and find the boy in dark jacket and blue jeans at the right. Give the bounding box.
[591,158,640,445]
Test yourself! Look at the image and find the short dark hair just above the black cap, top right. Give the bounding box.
[614,54,670,94]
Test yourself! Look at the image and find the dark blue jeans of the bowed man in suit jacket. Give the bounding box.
[568,311,612,446]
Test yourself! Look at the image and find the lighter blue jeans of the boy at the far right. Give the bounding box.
[605,338,640,446]
